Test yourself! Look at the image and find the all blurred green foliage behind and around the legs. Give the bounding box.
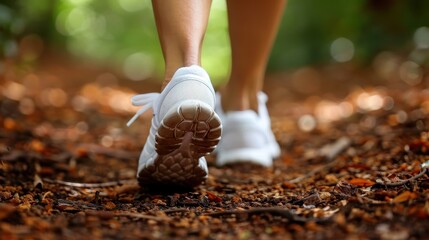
[0,0,429,81]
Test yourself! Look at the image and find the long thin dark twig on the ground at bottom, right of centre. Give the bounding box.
[205,207,331,223]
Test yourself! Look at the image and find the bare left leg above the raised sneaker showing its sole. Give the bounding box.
[152,0,211,87]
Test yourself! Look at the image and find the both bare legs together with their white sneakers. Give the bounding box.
[128,0,285,186]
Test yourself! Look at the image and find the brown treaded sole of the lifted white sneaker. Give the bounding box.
[139,100,222,187]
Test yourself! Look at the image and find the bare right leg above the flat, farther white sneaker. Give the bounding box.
[222,0,286,111]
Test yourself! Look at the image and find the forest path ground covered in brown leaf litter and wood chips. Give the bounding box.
[0,56,429,240]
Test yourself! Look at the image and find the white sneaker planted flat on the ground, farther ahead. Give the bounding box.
[216,92,280,167]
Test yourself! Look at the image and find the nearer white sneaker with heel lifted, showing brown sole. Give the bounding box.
[127,65,222,187]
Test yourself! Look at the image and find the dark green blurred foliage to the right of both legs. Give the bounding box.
[269,0,429,70]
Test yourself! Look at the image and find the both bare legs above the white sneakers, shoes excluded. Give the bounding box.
[153,0,285,112]
